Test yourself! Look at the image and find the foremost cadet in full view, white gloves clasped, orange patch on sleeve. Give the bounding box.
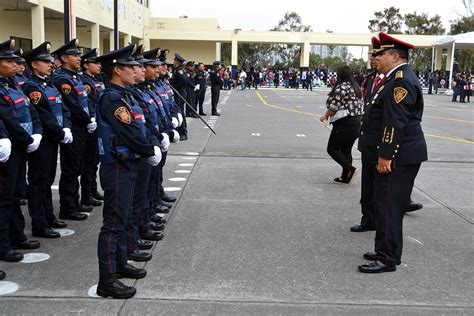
[96,45,161,298]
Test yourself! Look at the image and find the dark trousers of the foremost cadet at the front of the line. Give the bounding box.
[97,159,140,277]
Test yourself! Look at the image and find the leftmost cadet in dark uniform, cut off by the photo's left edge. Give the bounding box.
[0,40,43,262]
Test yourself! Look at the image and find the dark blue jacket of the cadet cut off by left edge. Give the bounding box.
[0,77,43,149]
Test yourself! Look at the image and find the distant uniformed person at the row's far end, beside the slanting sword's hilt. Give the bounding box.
[170,54,188,140]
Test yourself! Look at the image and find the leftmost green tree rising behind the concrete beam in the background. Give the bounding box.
[270,12,311,67]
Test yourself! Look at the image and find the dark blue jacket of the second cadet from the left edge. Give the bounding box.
[23,75,72,142]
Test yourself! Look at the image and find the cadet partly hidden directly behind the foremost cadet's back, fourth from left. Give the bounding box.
[81,48,105,206]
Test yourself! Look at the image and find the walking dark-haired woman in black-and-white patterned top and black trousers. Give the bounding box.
[319,66,363,184]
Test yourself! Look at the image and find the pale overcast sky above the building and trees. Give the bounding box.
[150,0,465,33]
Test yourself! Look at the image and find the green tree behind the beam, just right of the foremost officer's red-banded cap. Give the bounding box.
[404,11,446,72]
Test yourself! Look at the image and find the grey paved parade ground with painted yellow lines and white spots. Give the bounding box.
[0,88,474,315]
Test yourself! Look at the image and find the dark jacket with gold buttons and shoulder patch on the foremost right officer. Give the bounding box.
[359,64,428,165]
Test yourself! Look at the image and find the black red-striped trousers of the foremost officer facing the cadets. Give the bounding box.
[374,164,421,266]
